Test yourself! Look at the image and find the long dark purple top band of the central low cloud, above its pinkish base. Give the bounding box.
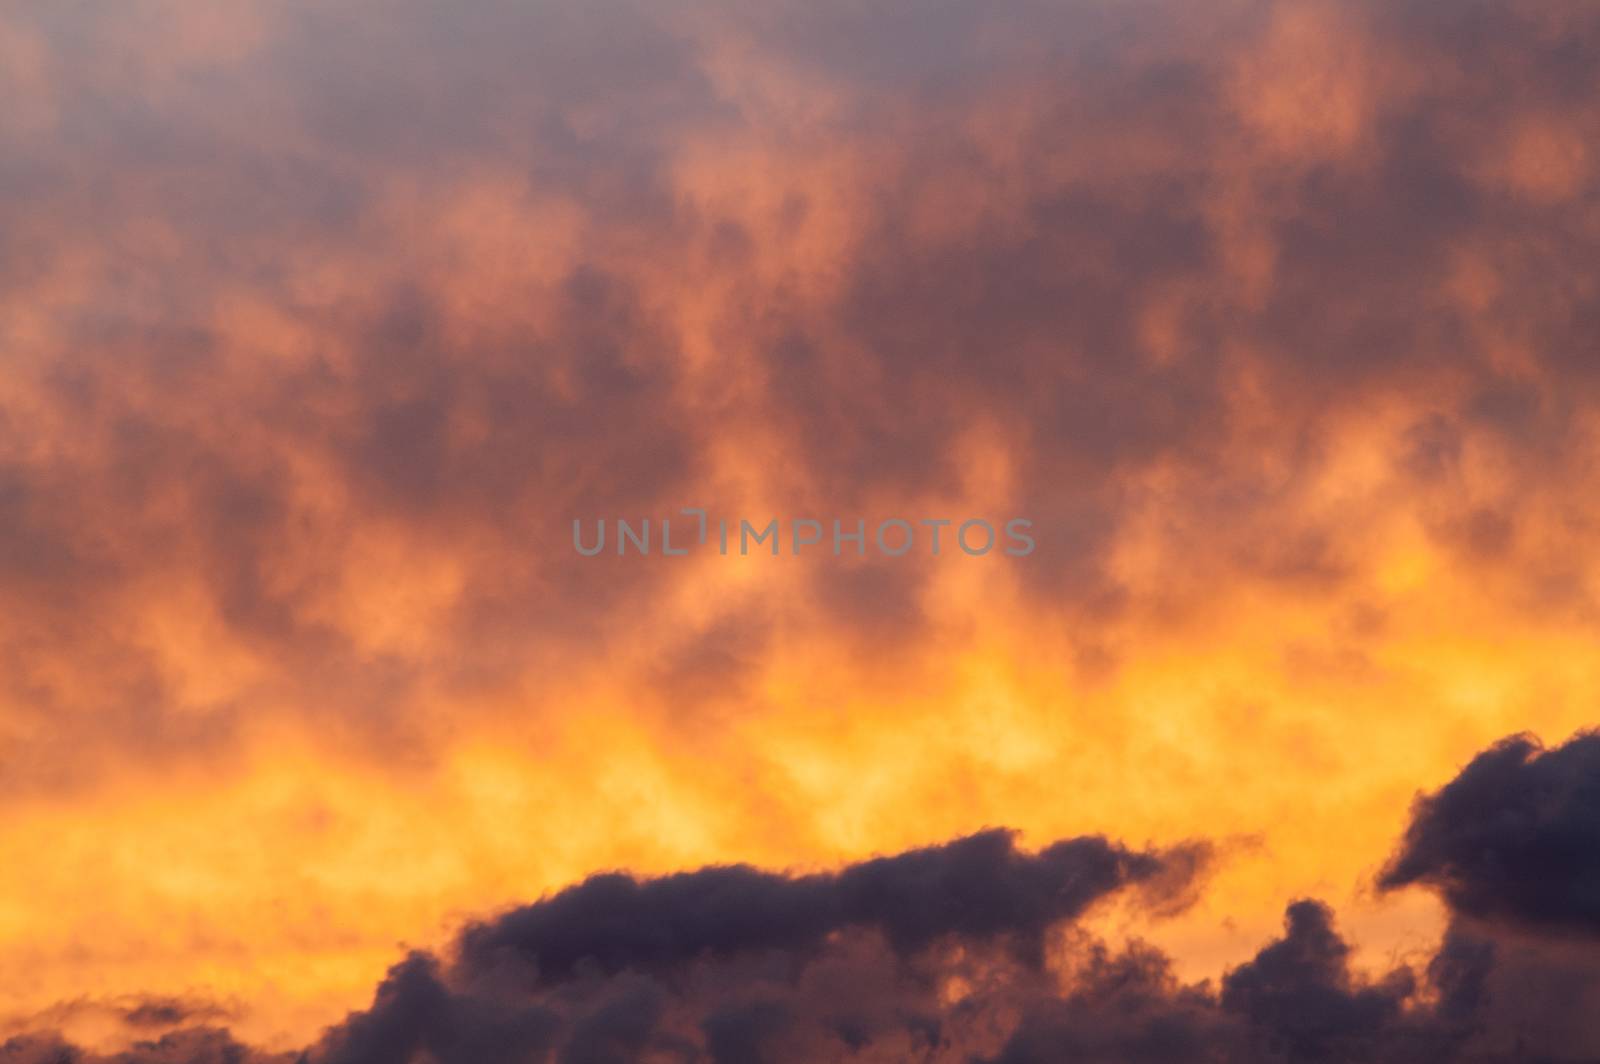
[462,830,1200,982]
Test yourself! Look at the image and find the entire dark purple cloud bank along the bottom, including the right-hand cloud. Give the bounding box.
[0,734,1600,1064]
